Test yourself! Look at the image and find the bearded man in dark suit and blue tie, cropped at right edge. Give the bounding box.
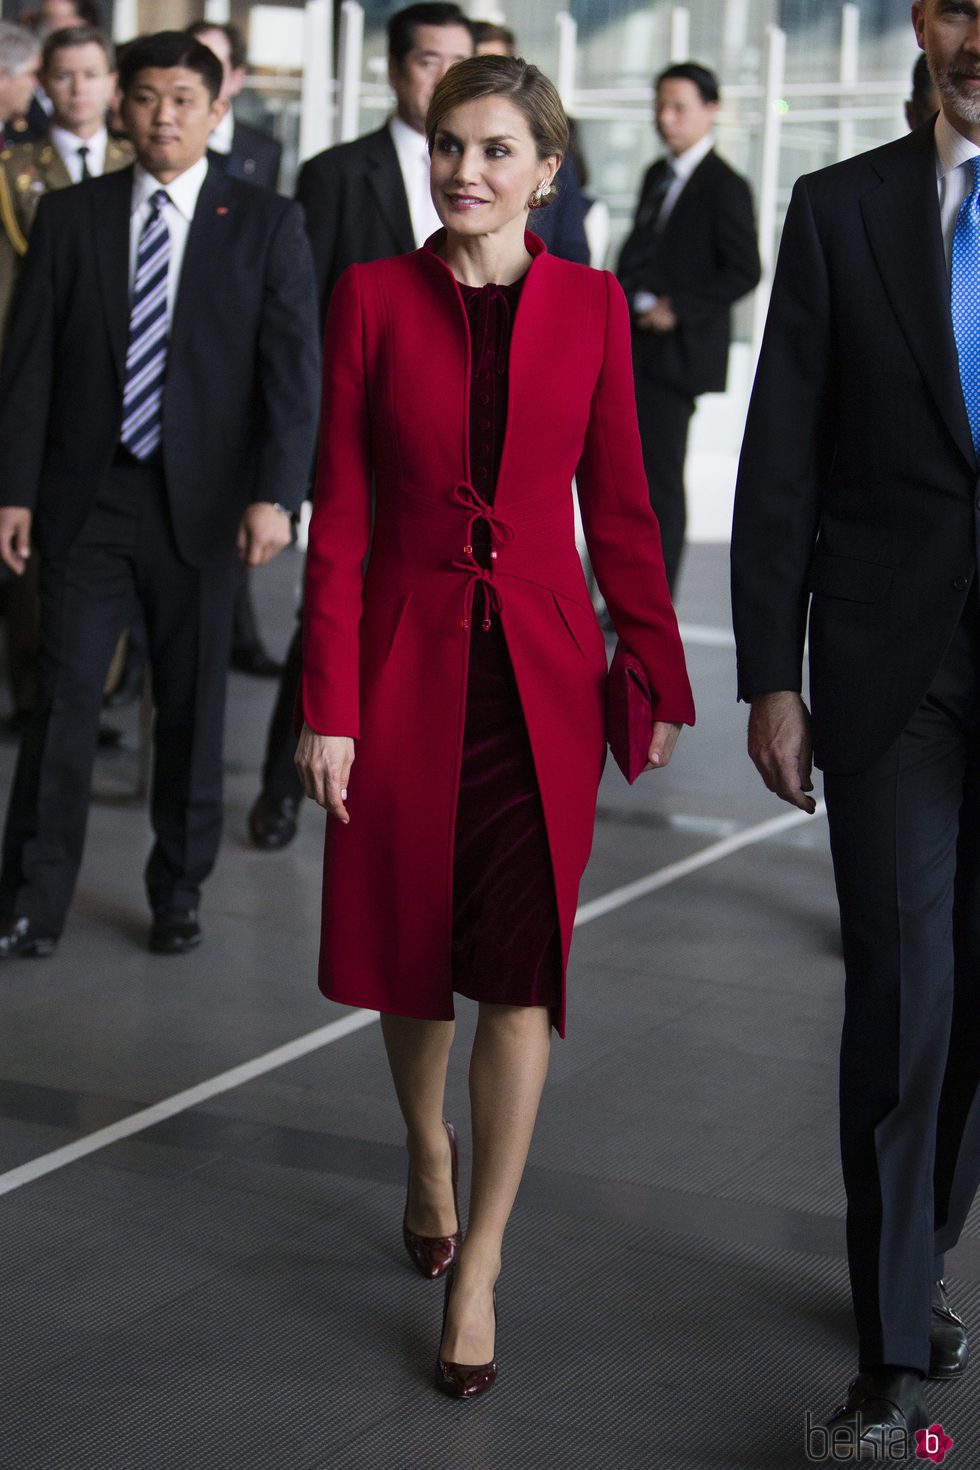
[732,0,980,1458]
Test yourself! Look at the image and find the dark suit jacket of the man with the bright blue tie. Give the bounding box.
[732,121,980,772]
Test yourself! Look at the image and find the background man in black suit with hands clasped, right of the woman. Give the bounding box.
[617,62,760,591]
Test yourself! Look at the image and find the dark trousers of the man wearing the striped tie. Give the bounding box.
[0,462,235,933]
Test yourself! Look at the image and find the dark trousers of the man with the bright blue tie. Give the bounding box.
[824,584,980,1372]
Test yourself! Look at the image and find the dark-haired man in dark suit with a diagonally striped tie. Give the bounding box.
[0,32,319,957]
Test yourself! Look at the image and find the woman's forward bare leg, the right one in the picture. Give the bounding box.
[439,1004,551,1364]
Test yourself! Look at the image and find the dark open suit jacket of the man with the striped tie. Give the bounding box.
[0,168,320,566]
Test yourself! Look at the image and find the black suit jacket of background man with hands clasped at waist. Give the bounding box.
[616,151,761,398]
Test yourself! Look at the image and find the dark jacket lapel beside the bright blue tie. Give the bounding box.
[861,126,977,469]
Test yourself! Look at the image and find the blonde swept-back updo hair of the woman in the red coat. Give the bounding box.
[426,56,569,209]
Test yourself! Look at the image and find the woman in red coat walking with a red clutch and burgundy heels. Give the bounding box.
[297,56,693,1397]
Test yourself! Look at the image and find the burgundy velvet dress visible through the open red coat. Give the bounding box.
[453,281,561,1014]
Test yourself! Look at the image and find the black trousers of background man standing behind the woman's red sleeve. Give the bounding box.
[635,360,695,594]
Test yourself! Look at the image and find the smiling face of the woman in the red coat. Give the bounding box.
[432,97,561,235]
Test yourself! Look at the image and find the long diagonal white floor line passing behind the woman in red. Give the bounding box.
[0,801,826,1195]
